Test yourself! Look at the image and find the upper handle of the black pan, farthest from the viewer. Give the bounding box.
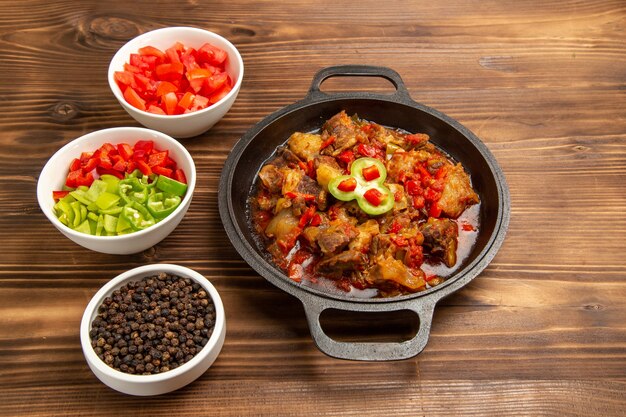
[308,65,413,102]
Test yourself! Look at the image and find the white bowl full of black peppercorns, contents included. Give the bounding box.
[80,264,226,396]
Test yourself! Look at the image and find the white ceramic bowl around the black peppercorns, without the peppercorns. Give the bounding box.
[80,264,226,396]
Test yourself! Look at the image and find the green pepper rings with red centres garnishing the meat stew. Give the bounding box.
[328,158,395,216]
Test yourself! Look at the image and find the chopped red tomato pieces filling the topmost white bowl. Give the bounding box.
[114,42,233,115]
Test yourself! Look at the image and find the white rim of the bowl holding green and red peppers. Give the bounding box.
[37,126,196,241]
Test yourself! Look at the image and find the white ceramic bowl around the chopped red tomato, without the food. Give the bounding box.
[108,27,243,138]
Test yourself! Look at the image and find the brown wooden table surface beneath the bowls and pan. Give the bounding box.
[0,0,626,416]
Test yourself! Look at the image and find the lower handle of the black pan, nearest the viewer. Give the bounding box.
[301,298,436,361]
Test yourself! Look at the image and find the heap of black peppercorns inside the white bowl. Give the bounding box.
[89,273,215,375]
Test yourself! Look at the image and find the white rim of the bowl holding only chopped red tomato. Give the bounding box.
[107,26,244,120]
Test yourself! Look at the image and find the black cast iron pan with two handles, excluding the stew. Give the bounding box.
[218,65,510,360]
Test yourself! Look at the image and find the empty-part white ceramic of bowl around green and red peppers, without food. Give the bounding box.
[37,127,196,255]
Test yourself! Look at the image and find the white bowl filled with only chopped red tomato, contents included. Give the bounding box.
[108,27,244,138]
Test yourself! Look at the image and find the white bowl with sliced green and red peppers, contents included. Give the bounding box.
[37,127,196,254]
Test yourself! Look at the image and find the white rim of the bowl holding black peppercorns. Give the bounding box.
[80,264,226,384]
